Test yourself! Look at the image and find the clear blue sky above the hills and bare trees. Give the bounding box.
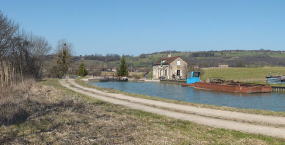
[0,0,285,56]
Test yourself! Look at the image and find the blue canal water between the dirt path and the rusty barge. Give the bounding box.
[90,82,285,112]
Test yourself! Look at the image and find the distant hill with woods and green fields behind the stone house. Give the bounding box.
[43,49,285,75]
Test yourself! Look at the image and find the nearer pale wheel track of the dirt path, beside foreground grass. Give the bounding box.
[61,80,285,138]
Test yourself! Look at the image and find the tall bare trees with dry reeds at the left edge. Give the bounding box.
[0,11,51,88]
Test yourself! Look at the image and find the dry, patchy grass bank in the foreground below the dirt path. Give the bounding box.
[0,80,285,144]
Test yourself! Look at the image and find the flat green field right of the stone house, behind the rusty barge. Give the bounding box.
[201,67,285,82]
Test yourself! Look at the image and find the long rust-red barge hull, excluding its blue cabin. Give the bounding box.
[195,82,271,93]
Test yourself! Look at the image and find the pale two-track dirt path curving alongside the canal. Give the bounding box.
[60,79,285,138]
